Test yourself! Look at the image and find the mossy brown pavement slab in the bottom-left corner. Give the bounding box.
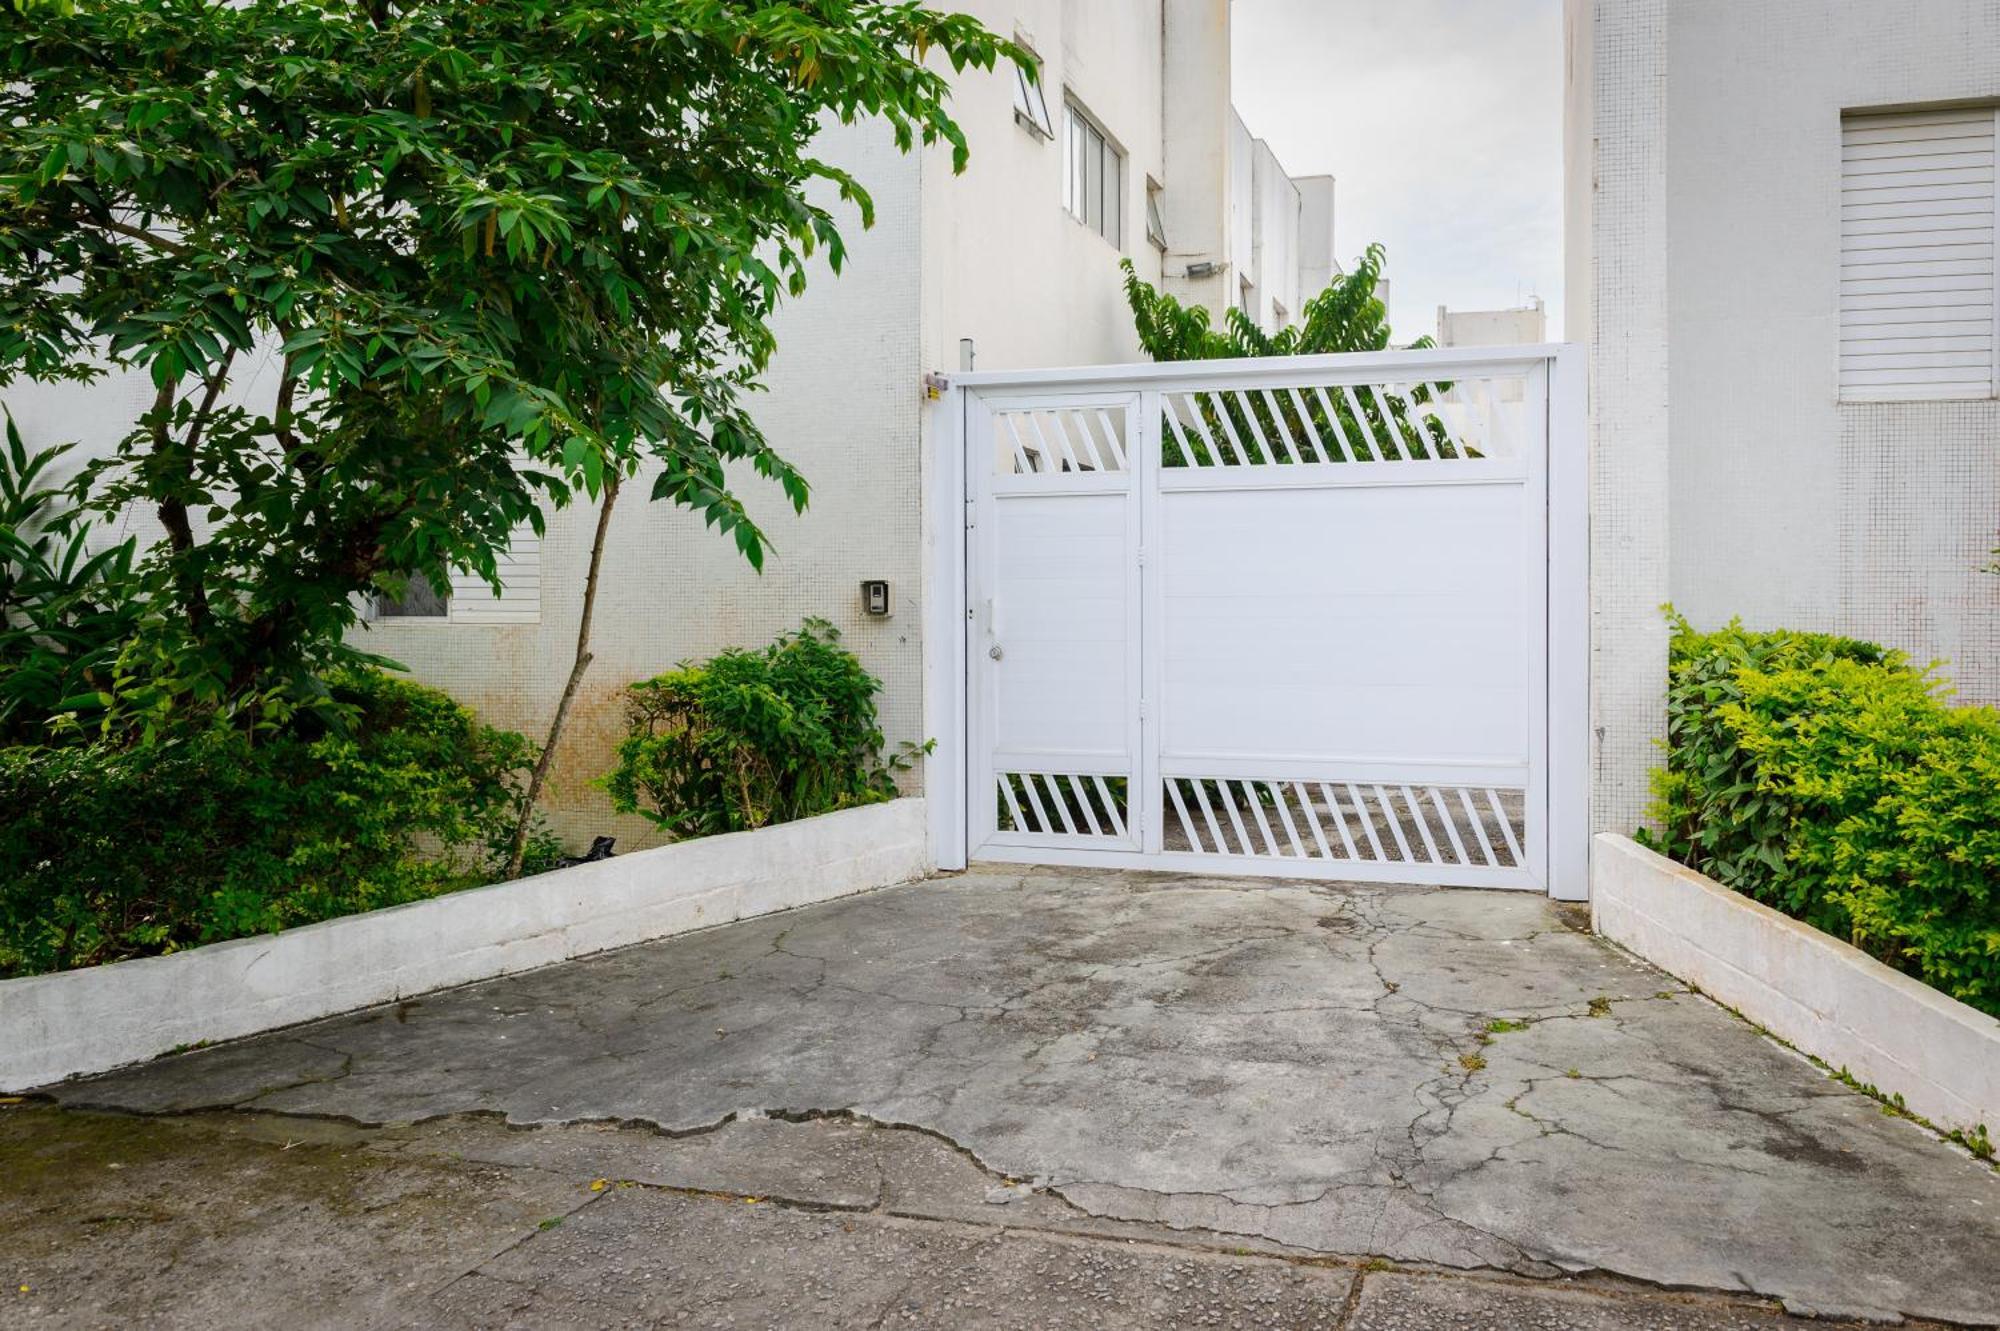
[0,1109,590,1327]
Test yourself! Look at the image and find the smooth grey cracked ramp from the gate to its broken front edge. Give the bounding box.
[31,871,2000,1323]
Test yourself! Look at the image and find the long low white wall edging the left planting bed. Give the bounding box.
[0,799,930,1091]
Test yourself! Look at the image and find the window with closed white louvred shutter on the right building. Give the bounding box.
[1840,108,2000,402]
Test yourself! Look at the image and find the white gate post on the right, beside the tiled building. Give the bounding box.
[1548,344,1590,901]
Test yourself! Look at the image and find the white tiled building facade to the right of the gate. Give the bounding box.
[1566,0,2000,829]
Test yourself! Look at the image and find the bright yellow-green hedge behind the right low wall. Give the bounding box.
[1642,618,2000,1015]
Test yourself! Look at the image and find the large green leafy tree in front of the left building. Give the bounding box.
[0,0,1018,721]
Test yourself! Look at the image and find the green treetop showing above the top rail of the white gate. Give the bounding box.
[1122,244,1432,360]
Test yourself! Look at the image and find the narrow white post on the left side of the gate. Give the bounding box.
[924,382,972,869]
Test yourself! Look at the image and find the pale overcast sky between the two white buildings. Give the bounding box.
[1232,0,1562,342]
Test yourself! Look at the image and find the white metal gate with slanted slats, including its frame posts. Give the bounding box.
[934,348,1588,895]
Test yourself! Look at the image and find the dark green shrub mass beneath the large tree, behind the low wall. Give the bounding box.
[0,671,534,975]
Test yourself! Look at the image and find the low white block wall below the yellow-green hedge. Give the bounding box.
[1590,833,2000,1131]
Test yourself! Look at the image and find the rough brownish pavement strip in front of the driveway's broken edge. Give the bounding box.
[0,1103,1944,1331]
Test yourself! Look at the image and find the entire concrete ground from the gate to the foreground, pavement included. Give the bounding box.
[0,869,2000,1327]
